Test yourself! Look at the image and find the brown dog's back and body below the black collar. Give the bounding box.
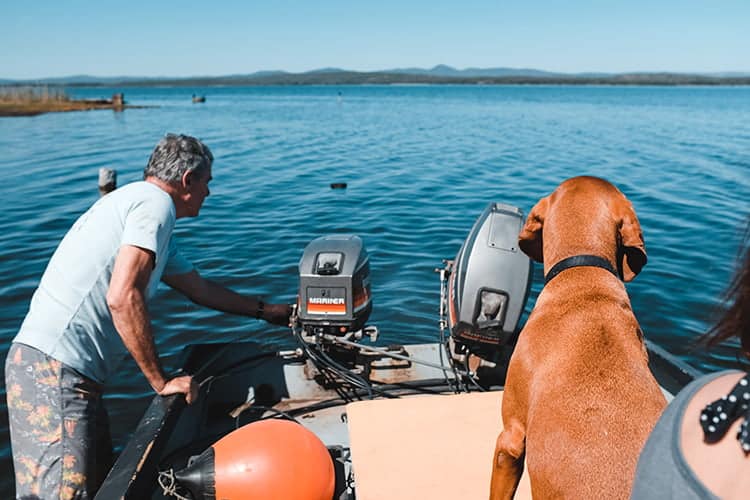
[516,268,665,499]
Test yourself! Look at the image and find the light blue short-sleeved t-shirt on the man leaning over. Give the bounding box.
[14,182,193,383]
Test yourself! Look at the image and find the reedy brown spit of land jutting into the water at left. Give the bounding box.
[0,85,140,117]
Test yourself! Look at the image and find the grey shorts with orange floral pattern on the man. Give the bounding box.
[5,343,112,500]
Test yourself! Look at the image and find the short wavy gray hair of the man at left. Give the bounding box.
[143,134,214,184]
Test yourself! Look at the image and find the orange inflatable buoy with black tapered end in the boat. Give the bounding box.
[175,419,336,500]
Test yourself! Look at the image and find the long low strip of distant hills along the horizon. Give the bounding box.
[0,64,750,86]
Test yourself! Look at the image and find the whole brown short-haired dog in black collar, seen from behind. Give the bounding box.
[490,177,666,500]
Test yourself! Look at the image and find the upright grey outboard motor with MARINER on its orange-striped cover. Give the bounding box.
[297,235,372,336]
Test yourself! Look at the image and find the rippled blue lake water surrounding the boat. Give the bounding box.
[0,86,750,497]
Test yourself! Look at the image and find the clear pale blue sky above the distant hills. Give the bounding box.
[0,0,750,78]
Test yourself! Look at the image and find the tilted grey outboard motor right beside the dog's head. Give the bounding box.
[446,203,532,368]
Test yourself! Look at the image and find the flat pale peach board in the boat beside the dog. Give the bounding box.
[347,391,531,500]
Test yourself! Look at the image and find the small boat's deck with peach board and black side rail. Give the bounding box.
[97,343,694,500]
